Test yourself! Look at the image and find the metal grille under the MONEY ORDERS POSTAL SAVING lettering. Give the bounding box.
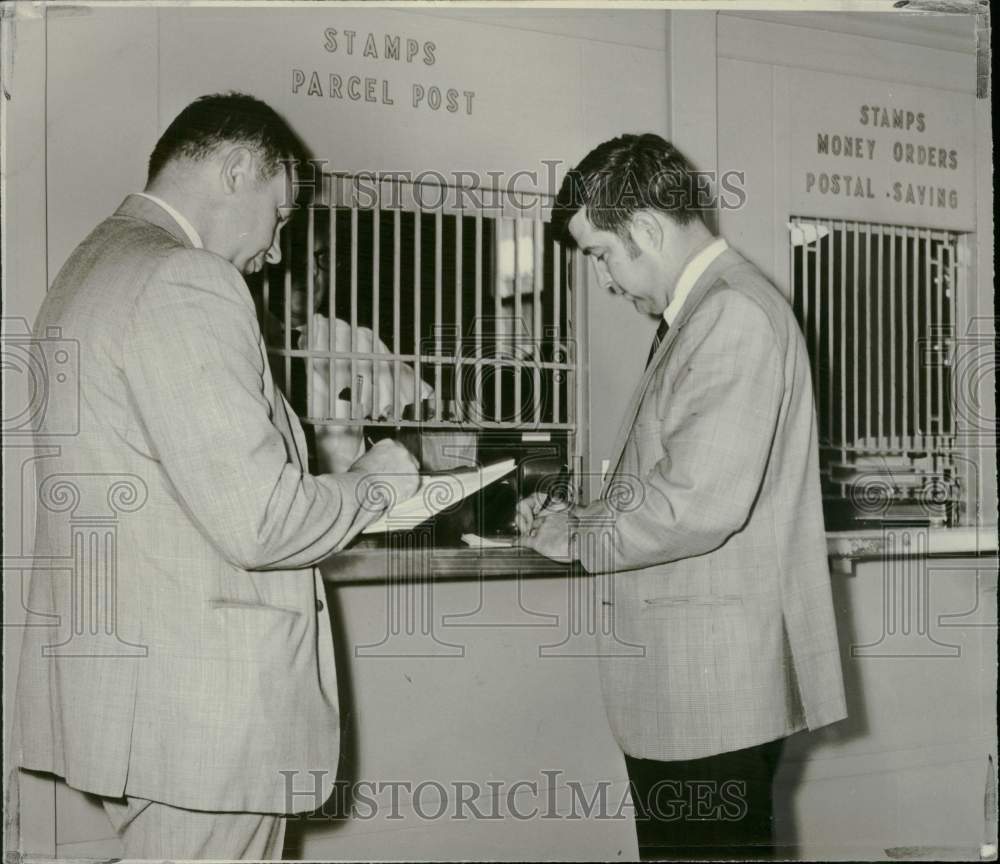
[789,217,960,528]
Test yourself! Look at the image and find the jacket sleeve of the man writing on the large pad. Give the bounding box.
[122,250,378,569]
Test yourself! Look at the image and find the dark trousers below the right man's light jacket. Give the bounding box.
[625,739,784,861]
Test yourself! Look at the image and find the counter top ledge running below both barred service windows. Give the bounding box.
[319,526,997,584]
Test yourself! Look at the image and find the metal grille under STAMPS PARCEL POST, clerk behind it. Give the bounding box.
[258,175,580,470]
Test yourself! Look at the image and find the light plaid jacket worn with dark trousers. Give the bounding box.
[576,249,847,760]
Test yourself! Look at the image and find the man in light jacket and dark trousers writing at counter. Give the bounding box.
[519,134,846,857]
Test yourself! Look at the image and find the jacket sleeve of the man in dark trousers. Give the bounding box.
[576,291,784,572]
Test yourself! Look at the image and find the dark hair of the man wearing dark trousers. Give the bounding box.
[552,132,702,245]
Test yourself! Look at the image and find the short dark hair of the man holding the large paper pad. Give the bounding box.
[147,91,308,183]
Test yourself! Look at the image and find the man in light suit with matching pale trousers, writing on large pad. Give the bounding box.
[18,94,417,859]
